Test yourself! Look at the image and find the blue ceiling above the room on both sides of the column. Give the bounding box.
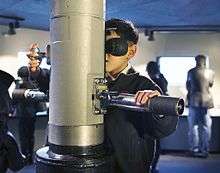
[0,0,220,30]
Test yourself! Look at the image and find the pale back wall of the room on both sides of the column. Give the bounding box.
[0,27,220,105]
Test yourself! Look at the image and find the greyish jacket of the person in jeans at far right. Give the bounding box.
[186,67,214,108]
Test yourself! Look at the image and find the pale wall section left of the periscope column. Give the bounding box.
[0,26,49,93]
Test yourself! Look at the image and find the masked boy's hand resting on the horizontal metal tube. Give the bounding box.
[135,90,161,105]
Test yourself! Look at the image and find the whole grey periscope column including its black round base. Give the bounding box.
[36,0,114,173]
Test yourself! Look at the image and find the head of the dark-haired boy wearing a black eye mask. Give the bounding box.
[105,19,138,75]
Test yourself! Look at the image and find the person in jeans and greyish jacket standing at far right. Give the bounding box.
[186,55,214,158]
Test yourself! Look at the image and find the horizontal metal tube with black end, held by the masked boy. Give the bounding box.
[107,93,184,116]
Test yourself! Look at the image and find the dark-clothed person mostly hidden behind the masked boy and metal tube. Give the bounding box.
[146,61,168,173]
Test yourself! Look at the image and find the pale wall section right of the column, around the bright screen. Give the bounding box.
[132,32,220,107]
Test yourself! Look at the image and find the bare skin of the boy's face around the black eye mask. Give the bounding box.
[105,31,136,75]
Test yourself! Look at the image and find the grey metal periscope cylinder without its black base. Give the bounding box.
[49,0,105,150]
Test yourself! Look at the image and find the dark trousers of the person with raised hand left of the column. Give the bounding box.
[19,117,36,161]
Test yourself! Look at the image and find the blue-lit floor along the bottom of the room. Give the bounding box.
[7,153,220,173]
